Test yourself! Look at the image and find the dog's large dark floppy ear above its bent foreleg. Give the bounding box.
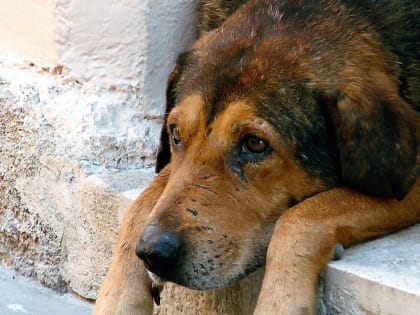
[331,75,420,199]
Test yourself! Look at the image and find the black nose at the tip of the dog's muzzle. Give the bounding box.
[136,229,182,277]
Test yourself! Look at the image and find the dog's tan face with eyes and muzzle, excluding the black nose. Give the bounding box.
[143,95,326,289]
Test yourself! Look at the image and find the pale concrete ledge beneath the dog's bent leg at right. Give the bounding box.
[324,224,420,315]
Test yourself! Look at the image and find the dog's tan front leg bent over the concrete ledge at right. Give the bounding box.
[254,180,420,315]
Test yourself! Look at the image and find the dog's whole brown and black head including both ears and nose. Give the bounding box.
[137,2,419,289]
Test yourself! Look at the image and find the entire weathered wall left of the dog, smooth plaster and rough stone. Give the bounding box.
[0,0,195,298]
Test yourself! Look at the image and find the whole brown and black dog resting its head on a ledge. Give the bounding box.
[95,0,420,315]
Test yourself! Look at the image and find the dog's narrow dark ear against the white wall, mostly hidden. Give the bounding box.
[155,52,189,173]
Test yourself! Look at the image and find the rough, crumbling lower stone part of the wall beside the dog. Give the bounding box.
[0,64,156,299]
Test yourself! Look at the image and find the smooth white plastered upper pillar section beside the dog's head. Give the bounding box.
[55,0,194,115]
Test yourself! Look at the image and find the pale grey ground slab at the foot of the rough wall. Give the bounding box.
[0,267,93,315]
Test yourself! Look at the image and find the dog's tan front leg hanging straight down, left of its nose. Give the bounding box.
[93,169,169,315]
